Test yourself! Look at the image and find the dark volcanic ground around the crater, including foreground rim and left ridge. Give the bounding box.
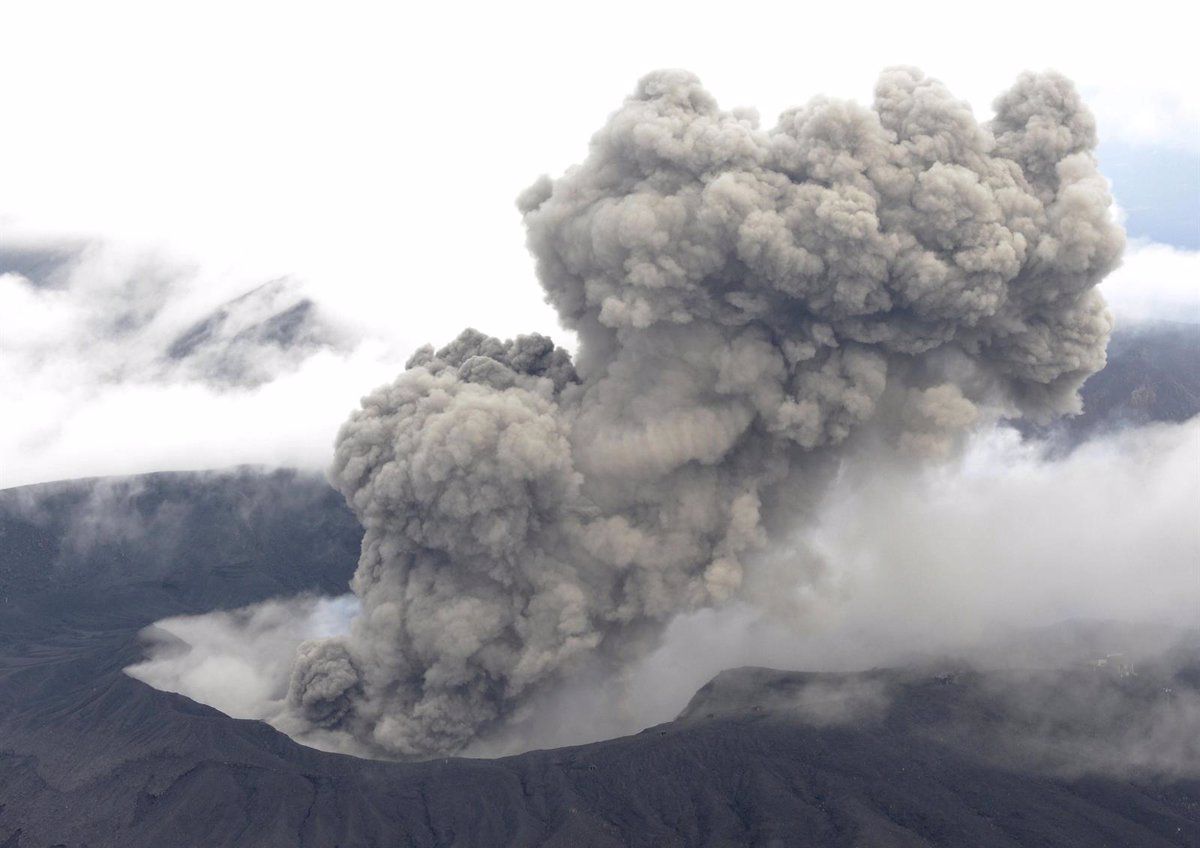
[0,473,1200,848]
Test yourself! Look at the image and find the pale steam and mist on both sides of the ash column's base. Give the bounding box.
[130,420,1200,756]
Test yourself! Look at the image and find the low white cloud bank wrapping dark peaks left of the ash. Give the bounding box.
[0,237,404,487]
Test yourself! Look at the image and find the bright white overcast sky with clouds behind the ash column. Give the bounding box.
[0,0,1200,486]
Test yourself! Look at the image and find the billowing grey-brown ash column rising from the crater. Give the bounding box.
[290,68,1123,756]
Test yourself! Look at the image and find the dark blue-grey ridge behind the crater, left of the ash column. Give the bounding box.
[0,469,362,618]
